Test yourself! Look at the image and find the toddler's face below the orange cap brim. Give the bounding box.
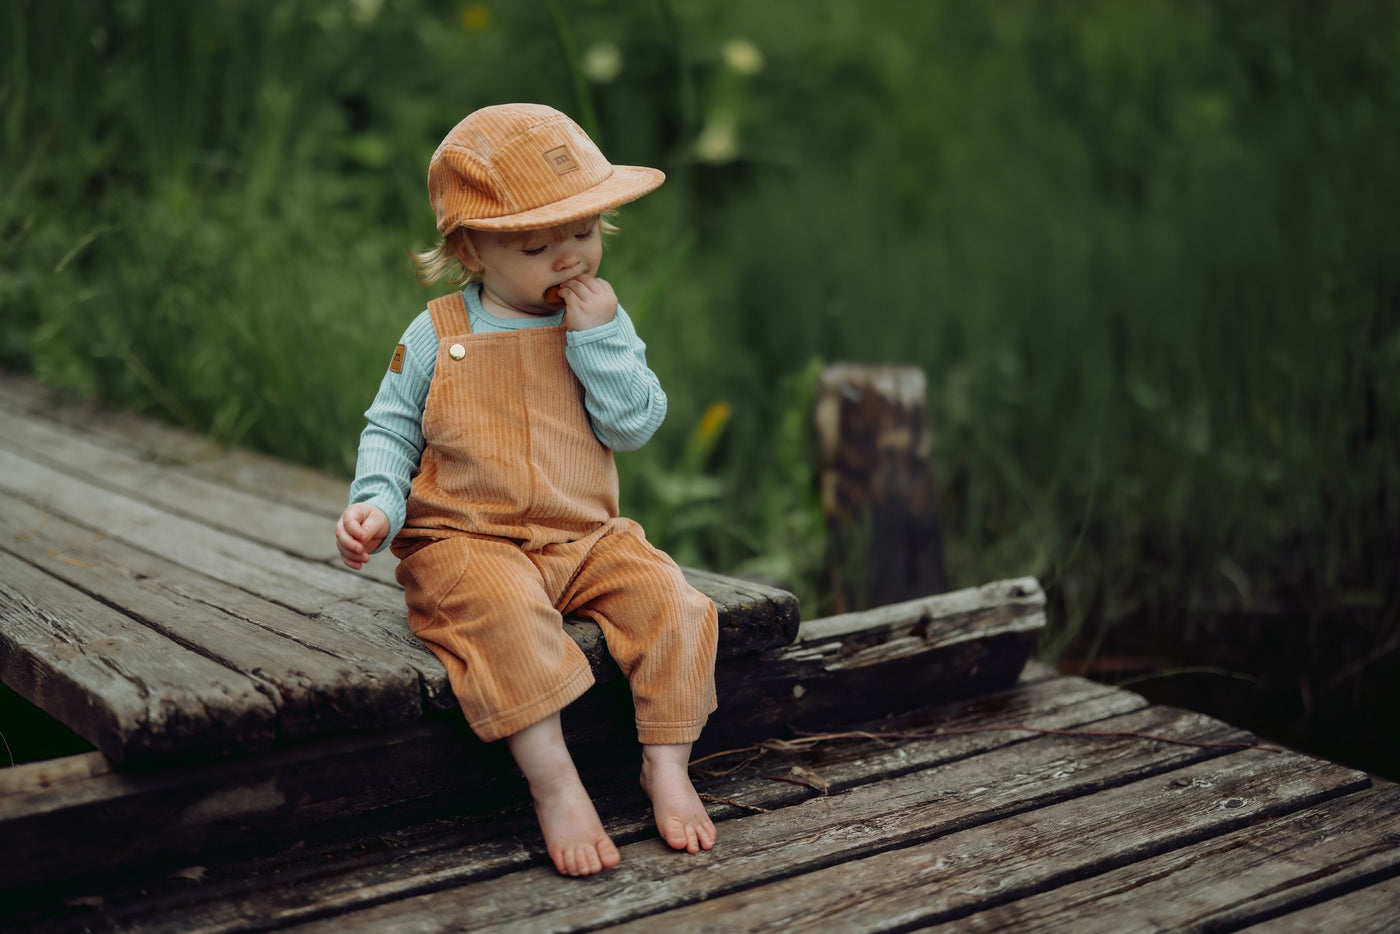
[469,217,603,318]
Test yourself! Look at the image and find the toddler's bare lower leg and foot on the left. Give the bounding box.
[505,713,621,875]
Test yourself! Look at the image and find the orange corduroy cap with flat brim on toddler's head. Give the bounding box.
[428,104,666,237]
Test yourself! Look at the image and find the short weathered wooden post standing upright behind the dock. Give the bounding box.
[815,364,948,613]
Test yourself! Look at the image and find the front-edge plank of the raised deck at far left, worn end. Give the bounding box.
[0,552,277,763]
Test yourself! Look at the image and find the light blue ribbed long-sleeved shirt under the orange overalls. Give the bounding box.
[350,283,666,550]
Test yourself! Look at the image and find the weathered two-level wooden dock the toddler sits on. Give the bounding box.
[0,377,1400,934]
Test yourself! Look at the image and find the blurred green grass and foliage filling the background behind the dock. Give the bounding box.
[0,0,1400,663]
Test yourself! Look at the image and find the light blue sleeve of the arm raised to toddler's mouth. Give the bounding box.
[566,307,666,451]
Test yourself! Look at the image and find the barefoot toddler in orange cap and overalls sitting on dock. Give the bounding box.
[336,104,718,875]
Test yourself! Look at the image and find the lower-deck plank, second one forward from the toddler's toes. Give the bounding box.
[596,752,1368,931]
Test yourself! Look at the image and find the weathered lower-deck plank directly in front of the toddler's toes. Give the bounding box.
[275,709,1260,931]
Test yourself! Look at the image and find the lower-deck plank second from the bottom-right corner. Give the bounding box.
[959,788,1400,934]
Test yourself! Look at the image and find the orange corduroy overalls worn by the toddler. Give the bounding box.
[392,293,718,744]
